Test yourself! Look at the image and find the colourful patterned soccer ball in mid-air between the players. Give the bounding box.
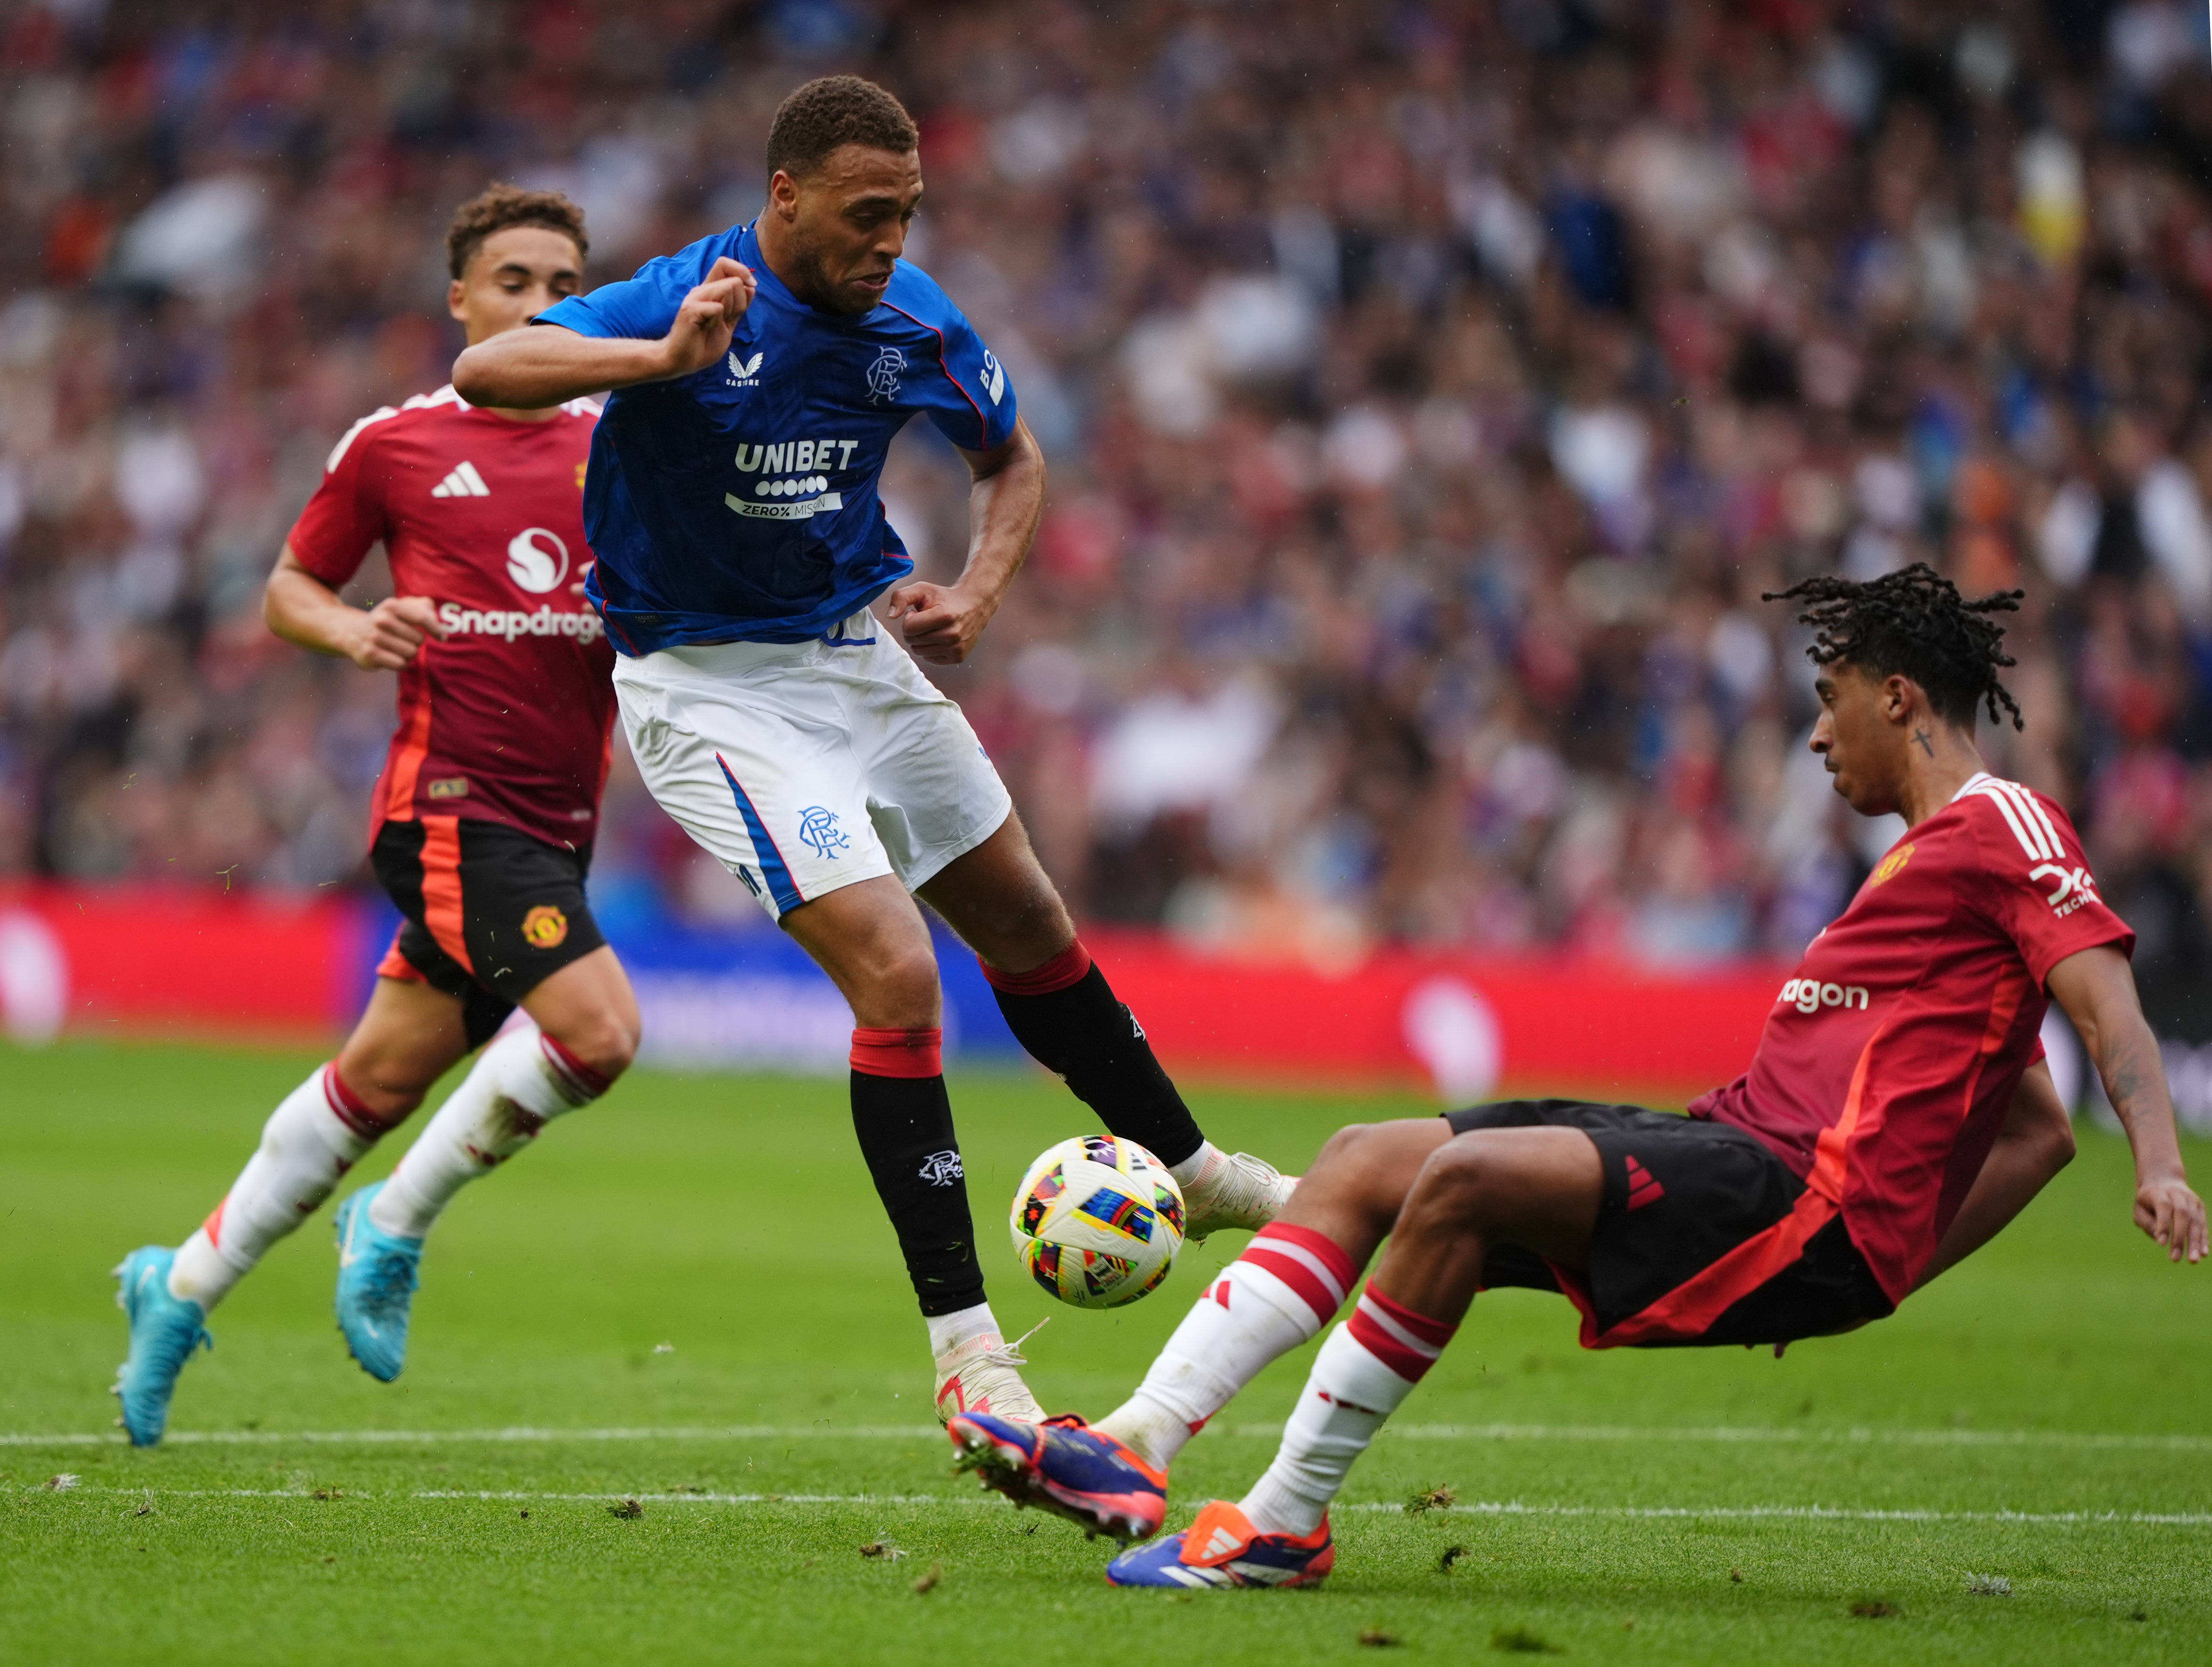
[1007,1134,1184,1309]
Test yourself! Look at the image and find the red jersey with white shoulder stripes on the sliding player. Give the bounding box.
[1690,774,2134,1302]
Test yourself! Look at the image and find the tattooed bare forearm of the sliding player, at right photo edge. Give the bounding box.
[2049,946,2208,1262]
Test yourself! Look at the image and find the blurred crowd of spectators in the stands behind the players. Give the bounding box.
[0,0,2212,1041]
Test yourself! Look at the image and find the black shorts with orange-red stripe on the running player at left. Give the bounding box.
[370,816,606,1048]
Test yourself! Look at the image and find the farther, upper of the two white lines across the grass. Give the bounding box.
[13,1424,2212,1453]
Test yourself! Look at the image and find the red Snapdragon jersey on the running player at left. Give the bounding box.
[292,387,615,847]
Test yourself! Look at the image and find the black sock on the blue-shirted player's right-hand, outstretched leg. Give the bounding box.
[982,942,1205,1170]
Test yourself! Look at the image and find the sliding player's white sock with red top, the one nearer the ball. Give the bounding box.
[1097,1223,1358,1470]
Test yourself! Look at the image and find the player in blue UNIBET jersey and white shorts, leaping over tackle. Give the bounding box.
[454,75,1294,1422]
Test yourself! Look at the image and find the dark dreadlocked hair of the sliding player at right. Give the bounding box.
[1763,561,2026,730]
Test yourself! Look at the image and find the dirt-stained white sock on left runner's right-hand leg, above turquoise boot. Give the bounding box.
[370,1026,606,1238]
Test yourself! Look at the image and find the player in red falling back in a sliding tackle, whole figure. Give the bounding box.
[951,566,2208,1587]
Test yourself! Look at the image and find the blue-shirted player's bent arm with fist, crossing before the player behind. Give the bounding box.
[454,254,754,411]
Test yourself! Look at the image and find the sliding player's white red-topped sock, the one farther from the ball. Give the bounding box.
[1239,1285,1458,1539]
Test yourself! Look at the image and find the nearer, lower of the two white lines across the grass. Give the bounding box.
[17,1481,2212,1528]
